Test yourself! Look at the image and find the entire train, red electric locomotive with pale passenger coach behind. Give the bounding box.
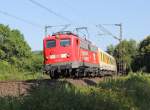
[43,31,117,79]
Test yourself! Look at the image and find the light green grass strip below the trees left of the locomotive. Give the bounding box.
[0,61,45,81]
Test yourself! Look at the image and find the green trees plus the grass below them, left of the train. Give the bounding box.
[0,24,43,80]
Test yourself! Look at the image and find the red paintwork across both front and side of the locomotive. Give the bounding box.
[43,34,98,64]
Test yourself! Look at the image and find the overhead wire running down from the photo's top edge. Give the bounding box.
[29,0,72,23]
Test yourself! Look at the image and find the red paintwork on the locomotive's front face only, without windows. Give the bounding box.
[44,35,76,64]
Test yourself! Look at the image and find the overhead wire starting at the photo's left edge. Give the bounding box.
[0,10,43,28]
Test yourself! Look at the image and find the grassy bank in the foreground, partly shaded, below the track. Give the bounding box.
[0,74,150,110]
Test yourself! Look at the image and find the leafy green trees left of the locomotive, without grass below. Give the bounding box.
[0,24,43,72]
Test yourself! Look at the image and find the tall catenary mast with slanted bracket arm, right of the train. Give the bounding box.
[97,23,126,75]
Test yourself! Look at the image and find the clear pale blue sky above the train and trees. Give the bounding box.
[0,0,150,51]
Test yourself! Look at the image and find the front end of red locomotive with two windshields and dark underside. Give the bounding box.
[43,33,78,78]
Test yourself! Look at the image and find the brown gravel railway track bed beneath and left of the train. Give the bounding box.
[0,77,113,96]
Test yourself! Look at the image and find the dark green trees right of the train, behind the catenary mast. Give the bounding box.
[107,36,150,73]
